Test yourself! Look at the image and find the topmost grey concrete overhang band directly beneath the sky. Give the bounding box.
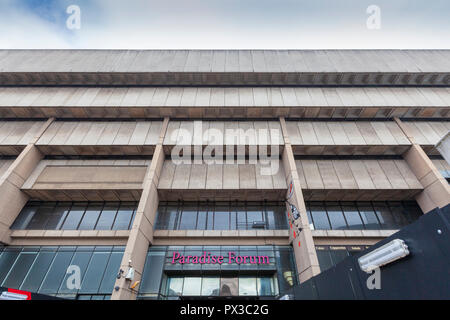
[0,50,450,86]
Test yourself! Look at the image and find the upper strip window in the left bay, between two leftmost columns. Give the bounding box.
[12,201,137,230]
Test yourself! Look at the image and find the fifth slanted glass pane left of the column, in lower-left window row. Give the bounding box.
[20,248,56,292]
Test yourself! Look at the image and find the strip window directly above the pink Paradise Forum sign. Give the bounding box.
[156,202,288,230]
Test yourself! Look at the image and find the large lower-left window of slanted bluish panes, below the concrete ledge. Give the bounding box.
[0,246,125,299]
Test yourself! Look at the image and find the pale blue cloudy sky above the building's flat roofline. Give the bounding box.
[0,0,450,49]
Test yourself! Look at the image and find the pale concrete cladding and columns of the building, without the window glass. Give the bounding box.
[0,50,450,300]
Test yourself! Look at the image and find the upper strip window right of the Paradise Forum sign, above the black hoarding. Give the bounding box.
[306,201,422,230]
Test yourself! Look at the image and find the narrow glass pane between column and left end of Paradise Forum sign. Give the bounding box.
[139,251,166,293]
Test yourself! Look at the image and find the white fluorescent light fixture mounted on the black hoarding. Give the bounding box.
[358,239,409,273]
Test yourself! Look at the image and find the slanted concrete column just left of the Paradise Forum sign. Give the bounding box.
[111,118,169,300]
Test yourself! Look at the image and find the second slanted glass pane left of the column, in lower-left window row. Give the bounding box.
[80,252,110,293]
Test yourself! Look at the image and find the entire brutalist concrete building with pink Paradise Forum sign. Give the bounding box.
[0,50,450,300]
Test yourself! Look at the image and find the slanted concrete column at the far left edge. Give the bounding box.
[0,118,54,244]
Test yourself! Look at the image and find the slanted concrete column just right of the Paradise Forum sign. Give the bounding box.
[280,118,320,283]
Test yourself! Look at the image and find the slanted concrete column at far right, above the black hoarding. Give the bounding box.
[395,118,450,213]
